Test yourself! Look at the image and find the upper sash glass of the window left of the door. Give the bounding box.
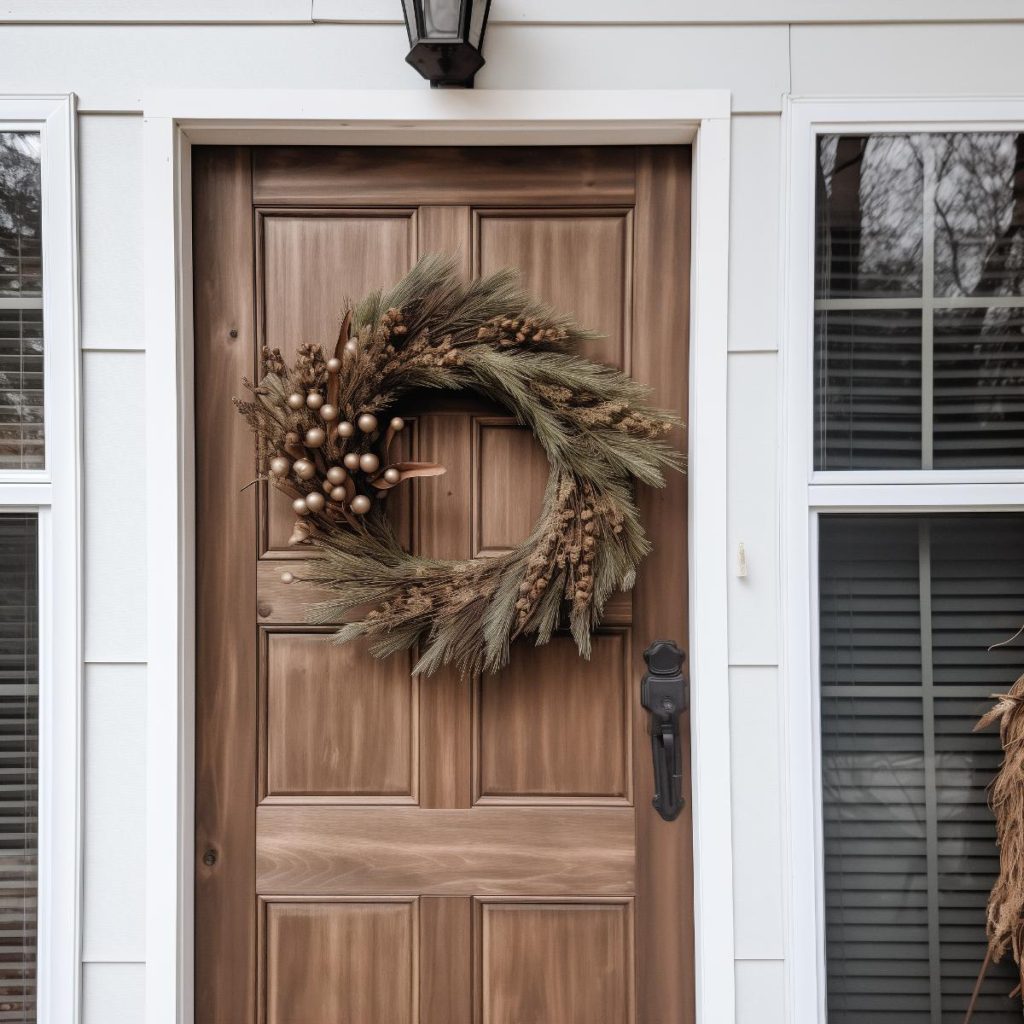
[0,132,44,469]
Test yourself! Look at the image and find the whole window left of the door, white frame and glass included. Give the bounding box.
[0,96,82,1024]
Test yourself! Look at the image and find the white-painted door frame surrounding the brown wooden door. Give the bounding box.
[143,89,735,1024]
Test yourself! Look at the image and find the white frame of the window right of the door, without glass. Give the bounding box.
[779,96,1024,1024]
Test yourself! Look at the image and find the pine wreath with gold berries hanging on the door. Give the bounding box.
[234,254,683,675]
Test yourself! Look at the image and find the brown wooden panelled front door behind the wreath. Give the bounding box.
[194,146,693,1024]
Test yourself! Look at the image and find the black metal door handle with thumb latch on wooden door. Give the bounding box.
[640,640,690,821]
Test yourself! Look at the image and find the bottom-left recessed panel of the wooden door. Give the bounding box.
[262,899,419,1024]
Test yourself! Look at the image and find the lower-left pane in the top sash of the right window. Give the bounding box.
[814,309,922,469]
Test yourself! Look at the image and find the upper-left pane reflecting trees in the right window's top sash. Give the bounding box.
[817,135,924,298]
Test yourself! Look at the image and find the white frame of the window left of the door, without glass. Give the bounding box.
[0,94,82,1024]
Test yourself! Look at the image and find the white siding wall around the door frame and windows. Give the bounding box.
[6,8,1024,1024]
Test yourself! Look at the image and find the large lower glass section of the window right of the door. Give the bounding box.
[819,514,1024,1024]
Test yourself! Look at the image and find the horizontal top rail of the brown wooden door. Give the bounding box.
[254,146,636,206]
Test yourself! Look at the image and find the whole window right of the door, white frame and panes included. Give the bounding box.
[782,100,1024,1024]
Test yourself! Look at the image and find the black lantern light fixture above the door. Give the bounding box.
[402,0,490,89]
